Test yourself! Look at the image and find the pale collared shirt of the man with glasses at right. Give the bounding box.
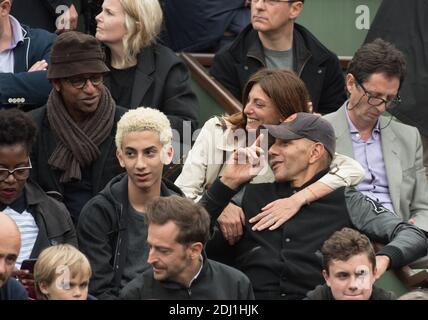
[346,109,394,212]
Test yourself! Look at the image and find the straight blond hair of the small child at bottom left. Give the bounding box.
[34,244,92,300]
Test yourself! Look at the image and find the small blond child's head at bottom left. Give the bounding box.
[34,244,92,300]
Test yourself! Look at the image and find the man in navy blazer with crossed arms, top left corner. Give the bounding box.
[0,0,55,110]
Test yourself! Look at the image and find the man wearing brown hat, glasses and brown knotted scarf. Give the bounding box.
[31,31,126,223]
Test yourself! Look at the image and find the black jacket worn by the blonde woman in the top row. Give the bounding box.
[104,44,199,136]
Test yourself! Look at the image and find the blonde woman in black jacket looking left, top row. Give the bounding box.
[95,0,199,135]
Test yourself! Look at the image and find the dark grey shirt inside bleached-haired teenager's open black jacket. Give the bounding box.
[121,205,150,287]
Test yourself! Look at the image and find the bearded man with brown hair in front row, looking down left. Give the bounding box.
[121,196,254,300]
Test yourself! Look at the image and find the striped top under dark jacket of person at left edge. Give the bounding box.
[3,207,39,269]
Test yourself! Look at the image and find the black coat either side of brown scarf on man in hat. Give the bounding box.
[30,106,127,202]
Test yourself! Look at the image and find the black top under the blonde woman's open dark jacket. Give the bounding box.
[106,66,137,108]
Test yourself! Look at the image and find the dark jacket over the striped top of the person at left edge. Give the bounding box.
[24,181,77,258]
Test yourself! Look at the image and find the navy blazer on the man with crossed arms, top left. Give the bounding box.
[0,26,55,110]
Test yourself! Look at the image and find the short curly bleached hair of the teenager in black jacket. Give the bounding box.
[115,107,172,150]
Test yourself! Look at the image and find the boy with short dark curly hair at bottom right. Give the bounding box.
[306,228,395,300]
